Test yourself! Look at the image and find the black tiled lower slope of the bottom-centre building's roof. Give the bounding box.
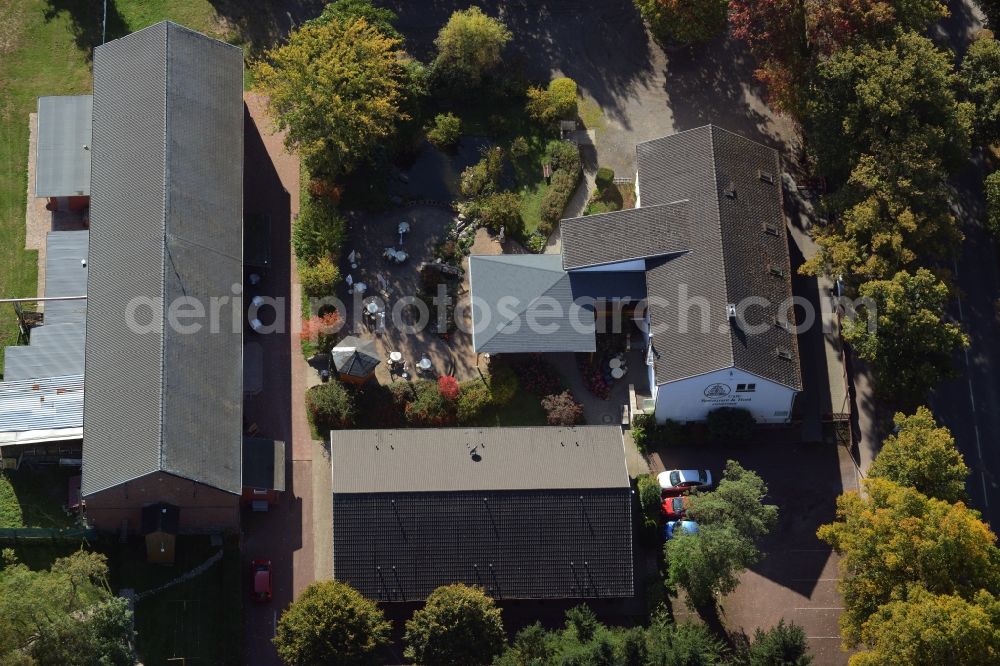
[333,486,634,601]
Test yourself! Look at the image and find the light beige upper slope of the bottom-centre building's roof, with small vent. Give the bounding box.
[330,426,629,493]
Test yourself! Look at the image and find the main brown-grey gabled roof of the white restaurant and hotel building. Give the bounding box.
[636,125,802,390]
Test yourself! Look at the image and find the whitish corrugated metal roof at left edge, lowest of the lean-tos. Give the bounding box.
[0,375,83,445]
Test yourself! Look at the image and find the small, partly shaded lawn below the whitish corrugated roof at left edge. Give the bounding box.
[0,467,77,528]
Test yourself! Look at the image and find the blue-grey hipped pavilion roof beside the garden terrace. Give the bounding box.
[469,254,596,354]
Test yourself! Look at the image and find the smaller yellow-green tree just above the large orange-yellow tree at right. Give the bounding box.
[868,407,969,502]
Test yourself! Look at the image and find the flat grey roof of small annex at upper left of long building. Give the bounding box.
[35,95,93,197]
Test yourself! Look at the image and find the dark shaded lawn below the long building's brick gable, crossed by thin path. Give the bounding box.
[100,537,243,666]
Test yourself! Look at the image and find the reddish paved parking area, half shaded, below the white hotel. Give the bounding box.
[650,437,857,666]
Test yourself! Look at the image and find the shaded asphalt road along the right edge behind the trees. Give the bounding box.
[931,0,1000,526]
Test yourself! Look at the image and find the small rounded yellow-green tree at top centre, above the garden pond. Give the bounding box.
[434,7,512,85]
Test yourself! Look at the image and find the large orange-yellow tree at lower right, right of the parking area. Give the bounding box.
[817,478,1000,646]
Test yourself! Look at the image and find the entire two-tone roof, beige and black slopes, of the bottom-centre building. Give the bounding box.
[330,426,634,601]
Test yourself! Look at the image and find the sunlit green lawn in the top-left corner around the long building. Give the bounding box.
[0,0,224,373]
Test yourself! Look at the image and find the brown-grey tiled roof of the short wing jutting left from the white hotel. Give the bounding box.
[559,201,692,271]
